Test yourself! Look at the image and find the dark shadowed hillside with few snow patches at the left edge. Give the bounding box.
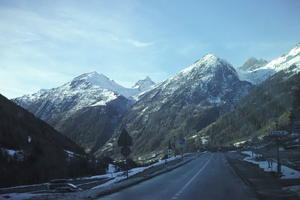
[0,95,86,186]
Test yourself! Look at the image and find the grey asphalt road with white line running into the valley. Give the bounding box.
[99,153,255,200]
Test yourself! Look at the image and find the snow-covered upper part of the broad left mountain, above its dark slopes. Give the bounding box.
[14,72,123,121]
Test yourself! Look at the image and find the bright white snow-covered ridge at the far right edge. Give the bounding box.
[239,43,300,85]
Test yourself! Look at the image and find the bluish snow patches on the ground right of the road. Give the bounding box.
[242,151,300,179]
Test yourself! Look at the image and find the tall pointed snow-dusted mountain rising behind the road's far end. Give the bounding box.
[97,54,252,159]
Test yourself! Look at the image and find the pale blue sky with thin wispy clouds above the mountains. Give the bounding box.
[0,0,300,98]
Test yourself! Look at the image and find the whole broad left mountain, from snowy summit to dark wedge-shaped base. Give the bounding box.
[13,72,134,151]
